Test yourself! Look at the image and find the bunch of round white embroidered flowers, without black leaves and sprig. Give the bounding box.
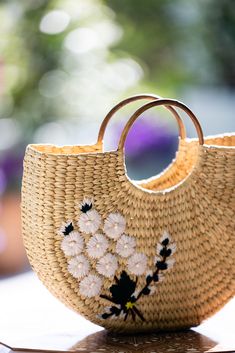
[59,198,147,297]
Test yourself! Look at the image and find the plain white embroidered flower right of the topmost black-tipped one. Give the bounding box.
[104,213,126,239]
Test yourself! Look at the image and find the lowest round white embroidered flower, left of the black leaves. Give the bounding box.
[79,274,102,298]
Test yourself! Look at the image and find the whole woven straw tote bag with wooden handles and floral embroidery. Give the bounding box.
[22,98,235,332]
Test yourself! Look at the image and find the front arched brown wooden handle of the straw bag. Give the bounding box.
[118,99,204,150]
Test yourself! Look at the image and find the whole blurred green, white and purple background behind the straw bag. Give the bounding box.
[0,0,235,274]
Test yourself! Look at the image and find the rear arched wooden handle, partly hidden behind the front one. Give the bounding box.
[97,94,186,144]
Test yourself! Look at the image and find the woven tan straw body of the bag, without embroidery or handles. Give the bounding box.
[22,99,235,332]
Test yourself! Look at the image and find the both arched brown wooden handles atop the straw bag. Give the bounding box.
[97,94,204,149]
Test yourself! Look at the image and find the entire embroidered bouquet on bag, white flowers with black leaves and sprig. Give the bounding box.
[59,198,176,321]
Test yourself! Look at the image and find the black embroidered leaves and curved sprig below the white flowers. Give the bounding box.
[100,234,176,321]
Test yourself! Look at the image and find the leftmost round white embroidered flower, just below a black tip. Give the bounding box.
[61,231,84,256]
